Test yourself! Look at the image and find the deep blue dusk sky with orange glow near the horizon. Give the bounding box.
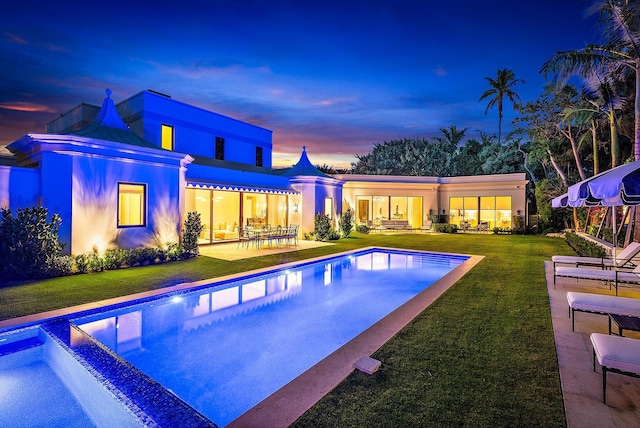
[0,0,598,168]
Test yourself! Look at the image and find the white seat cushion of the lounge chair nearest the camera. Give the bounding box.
[591,333,640,374]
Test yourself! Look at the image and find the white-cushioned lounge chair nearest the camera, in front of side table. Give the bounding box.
[591,333,640,404]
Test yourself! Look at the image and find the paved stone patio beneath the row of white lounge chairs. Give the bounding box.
[545,261,640,428]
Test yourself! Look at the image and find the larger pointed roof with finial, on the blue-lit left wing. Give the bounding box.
[69,89,160,149]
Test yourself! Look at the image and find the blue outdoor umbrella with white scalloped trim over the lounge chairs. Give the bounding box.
[551,161,640,264]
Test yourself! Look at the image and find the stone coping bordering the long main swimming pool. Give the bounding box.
[0,246,484,427]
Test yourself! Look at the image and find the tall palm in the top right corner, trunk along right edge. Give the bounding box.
[540,0,640,160]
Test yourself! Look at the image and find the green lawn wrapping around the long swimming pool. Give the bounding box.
[0,234,572,427]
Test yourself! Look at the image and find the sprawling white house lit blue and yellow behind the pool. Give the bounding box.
[0,90,527,254]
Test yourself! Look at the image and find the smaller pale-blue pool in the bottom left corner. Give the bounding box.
[0,327,142,428]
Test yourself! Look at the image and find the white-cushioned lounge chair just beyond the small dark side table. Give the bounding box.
[567,291,640,334]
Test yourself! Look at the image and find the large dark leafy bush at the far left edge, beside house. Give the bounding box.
[0,207,66,280]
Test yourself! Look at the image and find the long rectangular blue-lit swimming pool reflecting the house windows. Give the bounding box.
[0,249,468,426]
